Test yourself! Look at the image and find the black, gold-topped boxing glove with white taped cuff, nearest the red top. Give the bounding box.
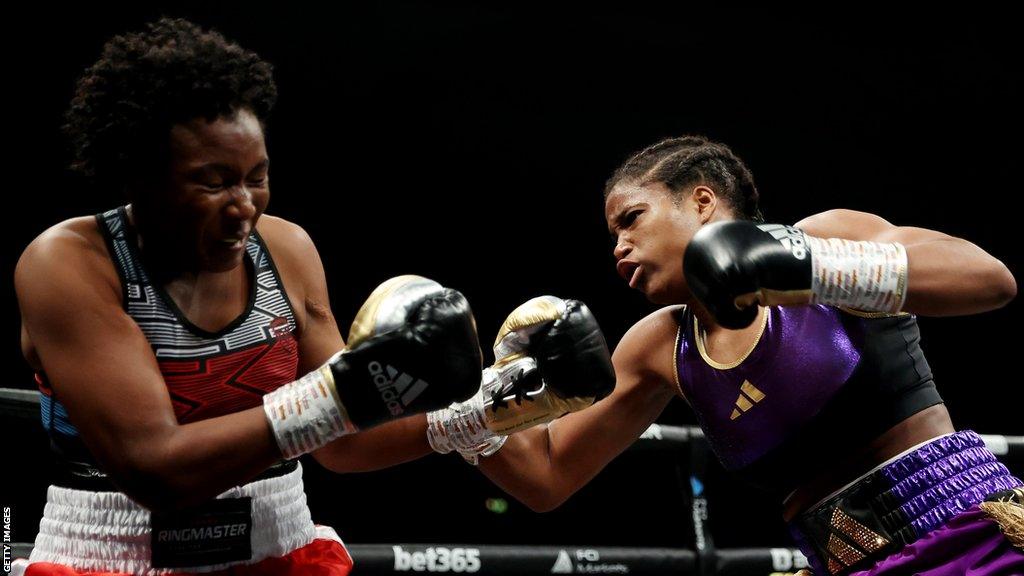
[263,276,481,458]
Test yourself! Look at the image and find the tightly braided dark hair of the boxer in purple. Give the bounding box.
[604,135,764,222]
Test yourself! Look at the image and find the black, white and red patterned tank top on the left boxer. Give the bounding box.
[36,207,299,464]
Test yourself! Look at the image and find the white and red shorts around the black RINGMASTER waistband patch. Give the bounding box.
[11,465,352,576]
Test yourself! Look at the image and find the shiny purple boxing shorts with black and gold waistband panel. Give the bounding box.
[791,430,1024,576]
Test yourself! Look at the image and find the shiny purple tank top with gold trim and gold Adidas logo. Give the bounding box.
[676,305,861,469]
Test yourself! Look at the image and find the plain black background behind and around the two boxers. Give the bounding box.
[0,3,1024,545]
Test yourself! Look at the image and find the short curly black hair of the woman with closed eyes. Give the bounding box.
[63,17,278,192]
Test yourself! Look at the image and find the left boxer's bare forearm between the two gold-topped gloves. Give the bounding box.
[312,414,432,474]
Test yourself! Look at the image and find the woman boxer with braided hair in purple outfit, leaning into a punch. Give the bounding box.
[480,136,1024,576]
